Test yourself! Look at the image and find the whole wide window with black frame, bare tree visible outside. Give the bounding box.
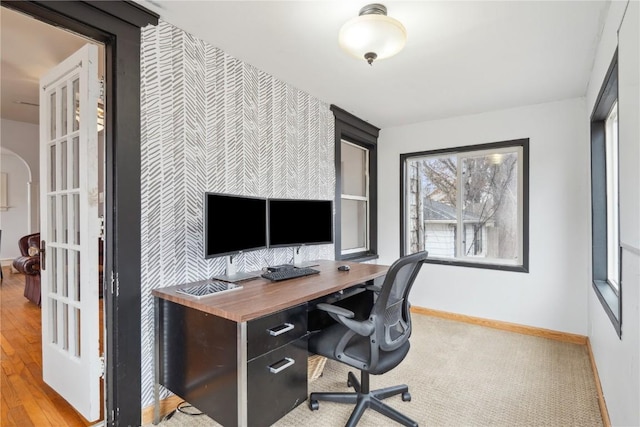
[400,139,529,272]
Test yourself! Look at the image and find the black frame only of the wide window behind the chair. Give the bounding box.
[400,138,529,273]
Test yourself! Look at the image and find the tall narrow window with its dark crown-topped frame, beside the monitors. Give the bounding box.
[331,105,380,261]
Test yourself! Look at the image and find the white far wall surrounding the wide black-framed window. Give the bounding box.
[378,99,590,335]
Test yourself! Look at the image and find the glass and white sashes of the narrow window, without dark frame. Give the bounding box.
[340,140,369,255]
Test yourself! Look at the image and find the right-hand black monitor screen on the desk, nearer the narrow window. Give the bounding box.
[269,199,333,247]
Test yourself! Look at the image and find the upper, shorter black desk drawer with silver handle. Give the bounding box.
[247,304,307,360]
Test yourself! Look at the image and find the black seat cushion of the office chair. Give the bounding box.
[309,323,410,375]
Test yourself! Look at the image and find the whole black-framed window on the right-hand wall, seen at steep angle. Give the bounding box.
[591,52,622,336]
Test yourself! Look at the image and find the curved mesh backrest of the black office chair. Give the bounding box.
[371,251,428,351]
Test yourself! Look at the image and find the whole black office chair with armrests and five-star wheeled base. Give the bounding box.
[309,251,427,427]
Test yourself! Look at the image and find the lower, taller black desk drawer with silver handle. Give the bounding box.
[247,337,308,427]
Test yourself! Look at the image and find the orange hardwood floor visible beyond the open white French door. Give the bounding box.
[0,267,95,427]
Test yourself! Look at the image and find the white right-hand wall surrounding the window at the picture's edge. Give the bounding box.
[585,1,640,426]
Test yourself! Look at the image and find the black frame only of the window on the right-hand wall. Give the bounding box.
[590,49,622,339]
